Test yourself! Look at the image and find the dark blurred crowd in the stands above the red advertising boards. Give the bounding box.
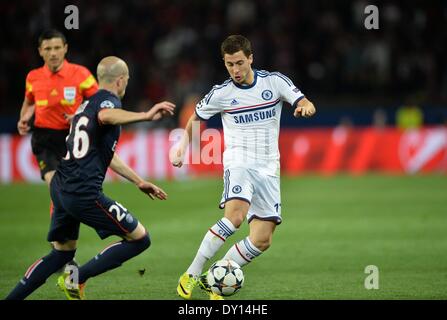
[0,0,447,126]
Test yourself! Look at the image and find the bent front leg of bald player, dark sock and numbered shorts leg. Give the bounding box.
[74,195,151,284]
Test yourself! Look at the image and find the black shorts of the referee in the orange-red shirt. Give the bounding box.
[31,127,69,180]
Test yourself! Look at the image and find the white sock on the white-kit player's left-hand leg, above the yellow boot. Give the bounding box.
[186,217,237,276]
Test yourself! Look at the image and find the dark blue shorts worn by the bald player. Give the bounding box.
[47,179,138,242]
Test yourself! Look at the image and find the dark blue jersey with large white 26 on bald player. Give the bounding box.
[56,90,121,197]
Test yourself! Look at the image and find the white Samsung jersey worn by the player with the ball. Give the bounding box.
[196,70,304,176]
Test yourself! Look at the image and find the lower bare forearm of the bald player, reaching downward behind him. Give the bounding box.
[109,153,168,200]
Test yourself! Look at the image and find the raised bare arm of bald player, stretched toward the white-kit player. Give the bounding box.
[98,101,175,125]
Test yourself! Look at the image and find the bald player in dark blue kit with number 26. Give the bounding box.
[6,57,175,300]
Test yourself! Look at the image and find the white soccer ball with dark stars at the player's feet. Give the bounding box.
[206,260,244,296]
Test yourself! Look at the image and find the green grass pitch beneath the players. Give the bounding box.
[0,175,447,299]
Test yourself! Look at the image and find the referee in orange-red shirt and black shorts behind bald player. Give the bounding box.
[17,30,98,185]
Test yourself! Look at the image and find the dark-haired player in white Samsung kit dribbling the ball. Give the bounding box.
[170,35,316,299]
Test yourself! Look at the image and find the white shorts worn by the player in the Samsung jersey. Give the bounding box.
[219,168,282,224]
